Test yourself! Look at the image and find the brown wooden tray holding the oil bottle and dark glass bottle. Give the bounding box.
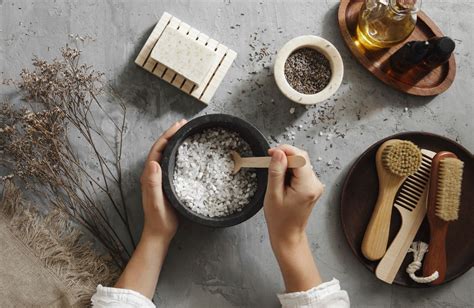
[338,0,456,96]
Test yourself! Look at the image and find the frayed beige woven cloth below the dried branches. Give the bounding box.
[0,181,119,308]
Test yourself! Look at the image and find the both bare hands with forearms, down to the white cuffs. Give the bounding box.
[115,120,323,298]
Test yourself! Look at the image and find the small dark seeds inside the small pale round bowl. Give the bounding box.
[285,48,331,94]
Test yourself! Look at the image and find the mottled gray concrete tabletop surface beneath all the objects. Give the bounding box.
[0,0,474,307]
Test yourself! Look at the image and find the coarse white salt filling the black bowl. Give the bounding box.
[173,128,257,217]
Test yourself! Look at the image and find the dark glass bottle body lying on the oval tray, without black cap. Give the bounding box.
[390,41,430,73]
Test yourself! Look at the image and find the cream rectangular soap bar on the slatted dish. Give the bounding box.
[150,27,218,87]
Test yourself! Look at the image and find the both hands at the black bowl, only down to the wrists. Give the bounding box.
[141,120,324,253]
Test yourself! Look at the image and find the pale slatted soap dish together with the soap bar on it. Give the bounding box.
[135,12,237,104]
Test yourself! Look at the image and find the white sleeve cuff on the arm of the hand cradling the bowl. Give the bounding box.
[91,285,156,308]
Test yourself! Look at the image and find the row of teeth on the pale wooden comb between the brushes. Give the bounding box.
[395,153,431,212]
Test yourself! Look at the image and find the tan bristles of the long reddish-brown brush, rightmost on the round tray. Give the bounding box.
[435,157,464,221]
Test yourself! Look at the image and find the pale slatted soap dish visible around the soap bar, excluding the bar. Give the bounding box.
[135,12,237,104]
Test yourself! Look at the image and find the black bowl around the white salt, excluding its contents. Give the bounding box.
[161,114,270,227]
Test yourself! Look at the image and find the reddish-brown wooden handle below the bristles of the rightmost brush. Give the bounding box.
[423,223,448,285]
